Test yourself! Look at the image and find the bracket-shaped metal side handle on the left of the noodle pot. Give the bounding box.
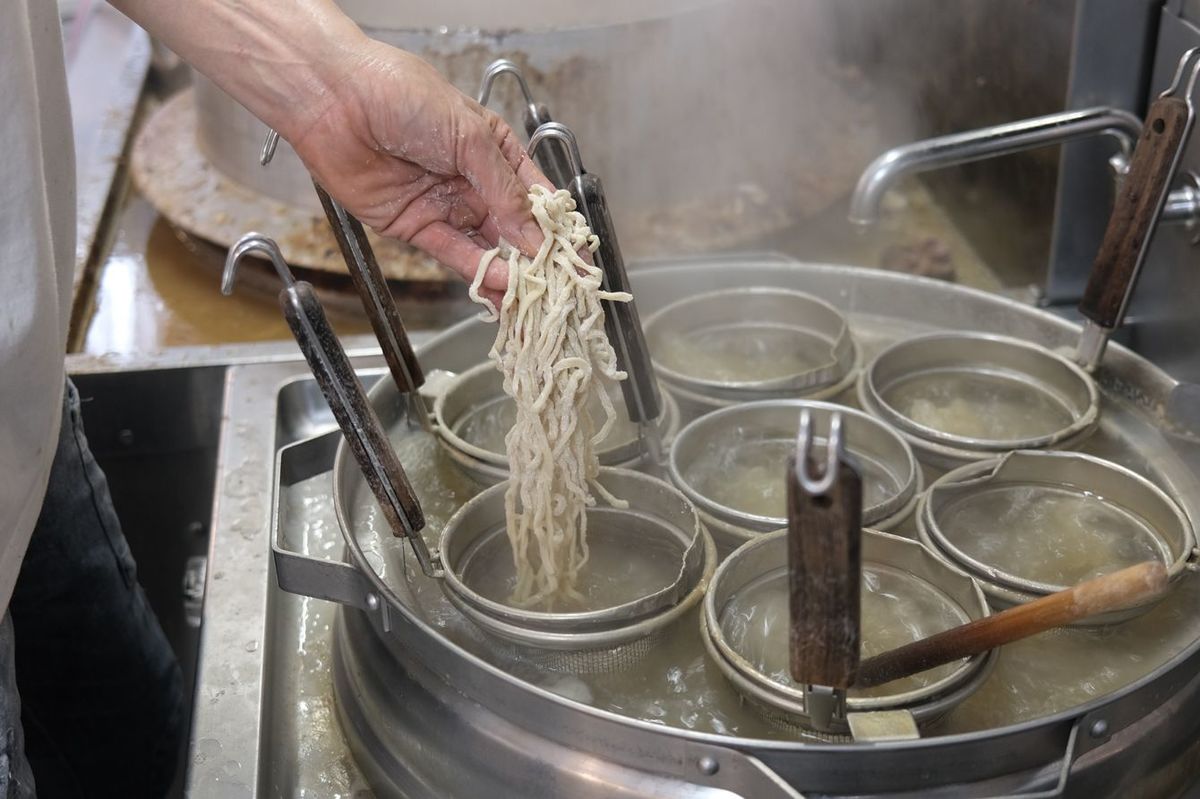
[271,431,371,611]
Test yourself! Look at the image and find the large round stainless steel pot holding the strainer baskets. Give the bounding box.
[276,262,1200,799]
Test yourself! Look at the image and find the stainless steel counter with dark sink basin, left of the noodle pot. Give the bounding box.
[68,338,398,799]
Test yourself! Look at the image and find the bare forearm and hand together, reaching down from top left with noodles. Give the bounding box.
[110,0,550,294]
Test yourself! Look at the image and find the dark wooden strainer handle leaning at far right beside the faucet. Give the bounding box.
[1079,97,1188,330]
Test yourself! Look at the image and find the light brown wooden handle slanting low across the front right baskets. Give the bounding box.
[854,560,1166,687]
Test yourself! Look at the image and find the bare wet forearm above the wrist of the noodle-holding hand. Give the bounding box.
[110,0,365,139]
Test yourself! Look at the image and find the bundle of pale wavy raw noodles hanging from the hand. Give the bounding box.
[470,186,632,607]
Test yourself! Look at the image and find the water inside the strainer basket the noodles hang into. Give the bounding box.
[458,507,684,613]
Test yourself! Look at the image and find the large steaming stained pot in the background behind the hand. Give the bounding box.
[189,0,883,254]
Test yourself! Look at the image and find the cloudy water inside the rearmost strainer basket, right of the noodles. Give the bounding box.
[653,323,833,383]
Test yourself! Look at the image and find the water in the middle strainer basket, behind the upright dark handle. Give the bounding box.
[683,436,900,515]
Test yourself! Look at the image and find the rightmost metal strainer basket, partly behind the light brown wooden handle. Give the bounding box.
[917,450,1195,626]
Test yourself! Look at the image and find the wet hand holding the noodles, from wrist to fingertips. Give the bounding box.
[284,40,550,293]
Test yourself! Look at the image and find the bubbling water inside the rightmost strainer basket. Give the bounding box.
[937,483,1172,587]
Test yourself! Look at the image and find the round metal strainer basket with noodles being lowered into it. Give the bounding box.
[438,468,716,673]
